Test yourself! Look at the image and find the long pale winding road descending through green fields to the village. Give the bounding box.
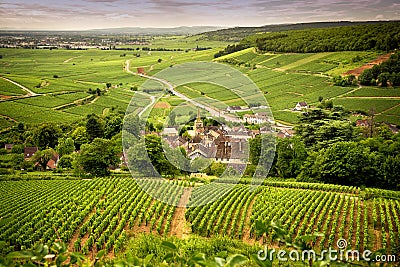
[125,60,243,123]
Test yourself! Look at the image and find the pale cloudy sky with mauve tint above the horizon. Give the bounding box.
[0,0,400,30]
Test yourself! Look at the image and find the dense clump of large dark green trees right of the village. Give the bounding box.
[270,103,400,190]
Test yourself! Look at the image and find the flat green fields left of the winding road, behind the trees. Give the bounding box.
[0,49,219,130]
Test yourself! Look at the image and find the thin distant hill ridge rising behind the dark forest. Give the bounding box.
[201,21,400,42]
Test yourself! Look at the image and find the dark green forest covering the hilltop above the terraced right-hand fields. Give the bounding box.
[215,22,400,57]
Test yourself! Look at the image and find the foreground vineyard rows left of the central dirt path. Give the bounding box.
[0,179,181,254]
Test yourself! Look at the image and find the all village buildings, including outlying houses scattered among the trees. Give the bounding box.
[0,102,307,171]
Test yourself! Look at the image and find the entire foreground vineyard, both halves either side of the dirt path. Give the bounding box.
[0,178,400,256]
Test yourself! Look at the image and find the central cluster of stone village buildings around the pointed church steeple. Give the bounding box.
[161,108,294,164]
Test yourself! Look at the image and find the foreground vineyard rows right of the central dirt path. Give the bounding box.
[186,182,400,253]
